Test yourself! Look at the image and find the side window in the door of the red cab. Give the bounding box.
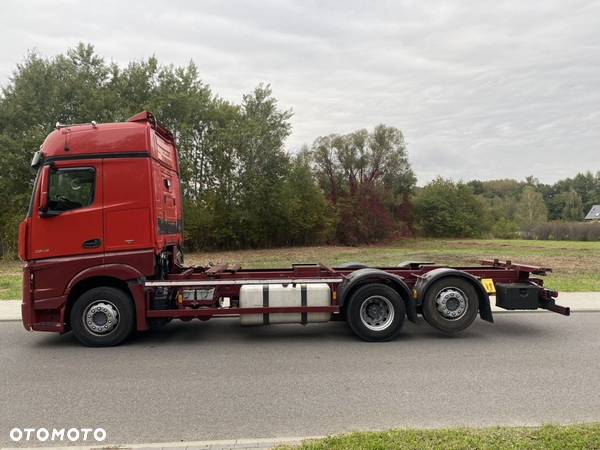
[48,167,96,212]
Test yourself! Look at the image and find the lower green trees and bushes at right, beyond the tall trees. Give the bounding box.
[413,172,600,240]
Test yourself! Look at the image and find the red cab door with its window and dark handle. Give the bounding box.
[29,159,104,259]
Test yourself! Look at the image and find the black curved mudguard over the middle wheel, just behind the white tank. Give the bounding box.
[338,268,417,322]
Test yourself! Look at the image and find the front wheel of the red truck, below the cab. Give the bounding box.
[70,287,135,347]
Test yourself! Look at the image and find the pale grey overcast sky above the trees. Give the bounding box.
[0,0,600,184]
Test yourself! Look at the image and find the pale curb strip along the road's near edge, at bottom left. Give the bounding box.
[1,436,326,450]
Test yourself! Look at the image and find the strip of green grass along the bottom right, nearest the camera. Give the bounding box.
[280,424,600,450]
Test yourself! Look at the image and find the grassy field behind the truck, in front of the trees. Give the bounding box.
[0,239,600,300]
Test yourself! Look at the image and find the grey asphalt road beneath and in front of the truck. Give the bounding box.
[0,312,600,446]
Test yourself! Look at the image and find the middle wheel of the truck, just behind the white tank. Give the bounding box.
[346,283,406,342]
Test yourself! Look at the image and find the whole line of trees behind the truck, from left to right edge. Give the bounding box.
[0,44,600,256]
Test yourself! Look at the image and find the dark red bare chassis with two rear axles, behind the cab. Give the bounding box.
[113,259,570,341]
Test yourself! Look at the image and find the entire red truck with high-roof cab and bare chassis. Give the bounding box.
[19,112,569,346]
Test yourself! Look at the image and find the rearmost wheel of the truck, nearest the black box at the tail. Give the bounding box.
[423,277,479,334]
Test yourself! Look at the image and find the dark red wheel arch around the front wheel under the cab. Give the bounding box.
[65,264,148,330]
